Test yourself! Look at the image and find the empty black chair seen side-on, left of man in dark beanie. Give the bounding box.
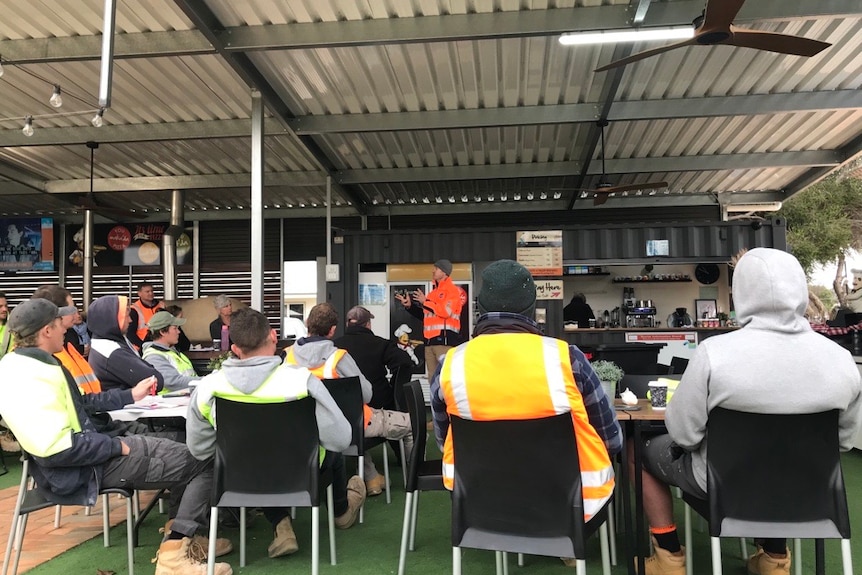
[398,381,446,575]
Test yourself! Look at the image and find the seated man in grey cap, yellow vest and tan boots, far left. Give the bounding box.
[0,299,233,575]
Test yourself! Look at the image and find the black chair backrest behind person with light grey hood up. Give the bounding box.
[707,408,850,539]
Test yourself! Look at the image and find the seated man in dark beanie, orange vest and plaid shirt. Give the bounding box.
[431,260,622,564]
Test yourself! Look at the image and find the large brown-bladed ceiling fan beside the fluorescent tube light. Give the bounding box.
[596,0,831,72]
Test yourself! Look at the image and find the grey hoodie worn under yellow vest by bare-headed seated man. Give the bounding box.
[186,355,352,460]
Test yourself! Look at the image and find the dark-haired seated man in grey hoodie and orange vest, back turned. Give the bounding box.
[284,303,413,495]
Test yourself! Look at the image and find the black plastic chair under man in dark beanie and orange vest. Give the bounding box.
[449,413,611,575]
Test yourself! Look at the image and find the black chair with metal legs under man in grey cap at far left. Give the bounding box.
[0,450,135,575]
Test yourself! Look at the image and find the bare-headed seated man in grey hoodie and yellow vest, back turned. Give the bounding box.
[187,308,365,557]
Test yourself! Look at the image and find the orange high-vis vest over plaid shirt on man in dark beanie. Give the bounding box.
[440,333,614,520]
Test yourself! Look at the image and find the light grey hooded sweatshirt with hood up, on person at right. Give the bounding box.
[665,248,862,491]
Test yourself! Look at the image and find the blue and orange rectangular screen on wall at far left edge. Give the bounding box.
[0,218,54,271]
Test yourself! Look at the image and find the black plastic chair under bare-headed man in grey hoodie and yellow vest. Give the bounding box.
[207,397,336,575]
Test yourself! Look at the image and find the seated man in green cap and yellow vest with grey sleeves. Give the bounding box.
[143,311,200,391]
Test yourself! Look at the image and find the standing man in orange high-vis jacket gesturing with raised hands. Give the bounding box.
[395,260,467,380]
